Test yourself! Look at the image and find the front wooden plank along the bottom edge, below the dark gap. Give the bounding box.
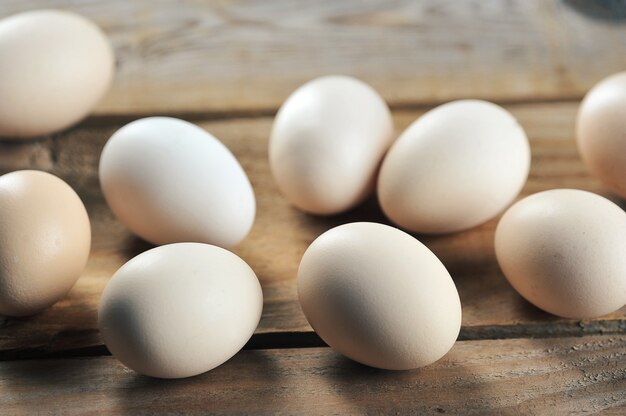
[0,336,626,415]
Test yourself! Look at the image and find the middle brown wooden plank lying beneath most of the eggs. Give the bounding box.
[0,103,626,359]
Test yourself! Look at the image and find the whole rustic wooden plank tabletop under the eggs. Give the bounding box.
[0,0,626,415]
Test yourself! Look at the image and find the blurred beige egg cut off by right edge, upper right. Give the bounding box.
[576,72,626,198]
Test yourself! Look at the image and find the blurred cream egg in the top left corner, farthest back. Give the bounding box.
[0,10,114,139]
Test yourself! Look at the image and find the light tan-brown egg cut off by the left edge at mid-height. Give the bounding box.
[0,170,91,316]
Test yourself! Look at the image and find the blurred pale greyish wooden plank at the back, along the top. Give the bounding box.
[0,0,626,114]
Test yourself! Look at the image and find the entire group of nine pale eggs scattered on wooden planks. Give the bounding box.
[0,11,626,378]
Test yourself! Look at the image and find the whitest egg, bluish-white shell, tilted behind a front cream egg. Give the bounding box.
[100,117,256,247]
